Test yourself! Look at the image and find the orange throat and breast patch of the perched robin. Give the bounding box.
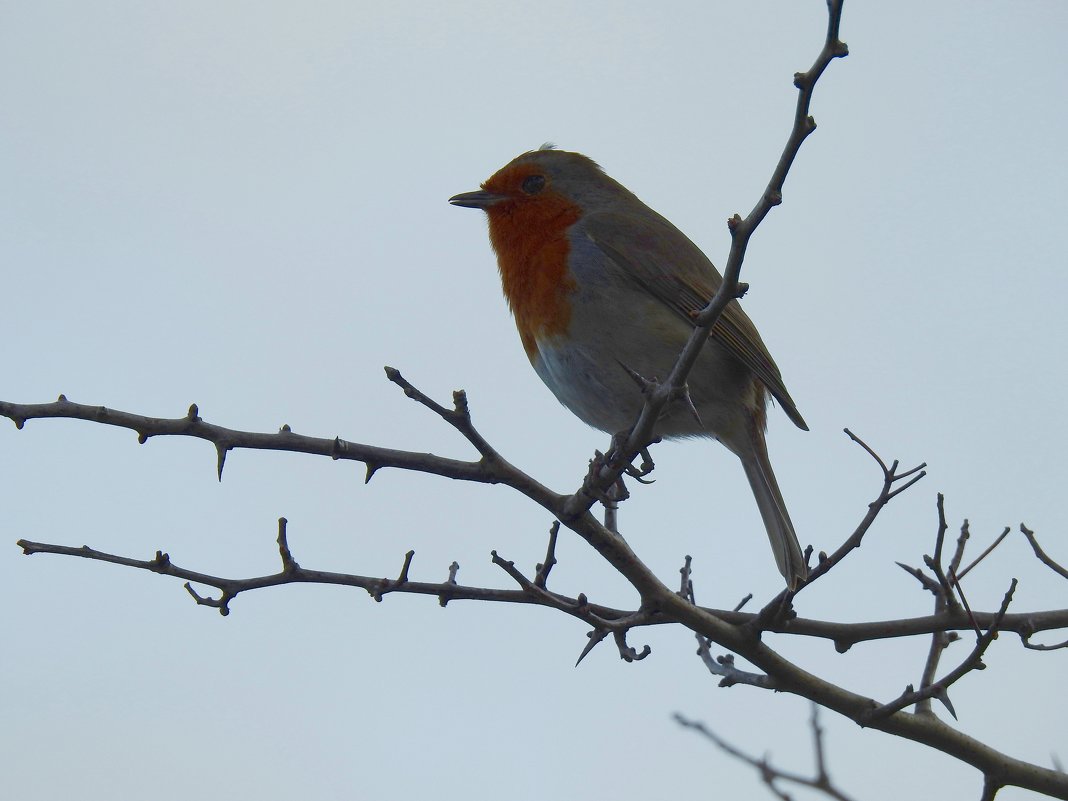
[487,191,581,362]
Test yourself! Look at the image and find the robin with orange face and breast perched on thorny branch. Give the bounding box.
[449,144,808,590]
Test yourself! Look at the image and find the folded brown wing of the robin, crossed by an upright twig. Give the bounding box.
[583,213,808,430]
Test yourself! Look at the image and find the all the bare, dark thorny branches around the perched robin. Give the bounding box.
[0,0,1068,799]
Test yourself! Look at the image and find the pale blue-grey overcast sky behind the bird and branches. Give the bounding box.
[0,0,1068,801]
